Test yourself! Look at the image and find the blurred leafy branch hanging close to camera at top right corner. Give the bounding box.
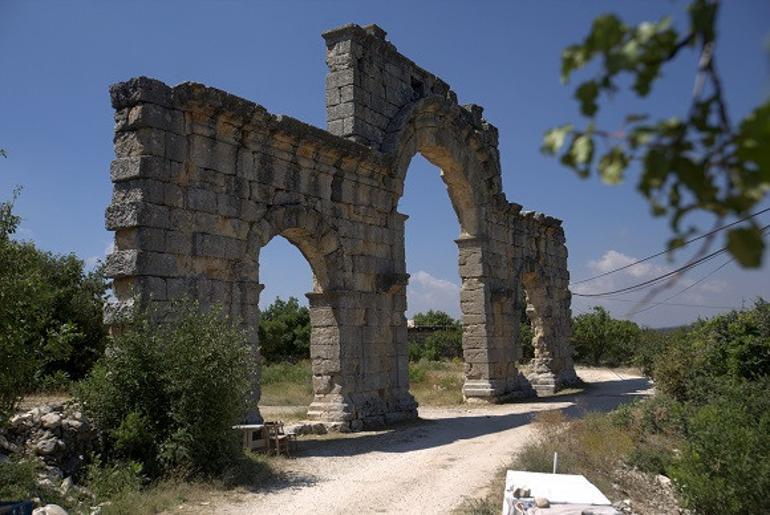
[542,0,770,267]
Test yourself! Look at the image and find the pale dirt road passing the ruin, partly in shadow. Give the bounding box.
[207,369,650,514]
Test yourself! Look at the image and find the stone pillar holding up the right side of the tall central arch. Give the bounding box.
[456,238,522,403]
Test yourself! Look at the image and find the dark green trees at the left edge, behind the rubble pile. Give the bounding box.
[0,191,107,415]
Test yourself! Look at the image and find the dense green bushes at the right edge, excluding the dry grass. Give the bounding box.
[640,300,770,513]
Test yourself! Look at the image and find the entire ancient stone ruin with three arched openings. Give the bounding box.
[106,25,577,429]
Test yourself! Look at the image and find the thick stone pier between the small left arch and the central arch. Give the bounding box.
[307,292,417,431]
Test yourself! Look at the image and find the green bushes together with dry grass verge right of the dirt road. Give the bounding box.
[461,300,770,514]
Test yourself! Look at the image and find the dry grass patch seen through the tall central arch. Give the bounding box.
[409,360,465,406]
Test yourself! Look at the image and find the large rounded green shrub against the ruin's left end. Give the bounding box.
[77,302,255,477]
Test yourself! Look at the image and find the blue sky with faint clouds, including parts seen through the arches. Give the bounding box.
[0,0,770,326]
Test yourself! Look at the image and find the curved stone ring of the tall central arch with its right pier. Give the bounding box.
[381,95,528,402]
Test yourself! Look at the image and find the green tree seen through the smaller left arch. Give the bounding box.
[259,297,310,363]
